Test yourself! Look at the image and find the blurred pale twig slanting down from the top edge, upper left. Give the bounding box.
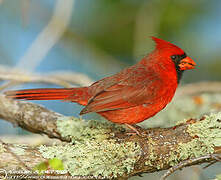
[17,0,75,72]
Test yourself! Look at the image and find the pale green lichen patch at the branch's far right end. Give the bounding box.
[168,113,221,166]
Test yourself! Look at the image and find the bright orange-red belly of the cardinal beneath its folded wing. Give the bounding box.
[98,102,168,124]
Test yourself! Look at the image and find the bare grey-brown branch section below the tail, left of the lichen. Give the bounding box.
[0,95,70,141]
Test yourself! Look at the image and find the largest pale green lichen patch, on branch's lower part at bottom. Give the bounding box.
[39,139,141,177]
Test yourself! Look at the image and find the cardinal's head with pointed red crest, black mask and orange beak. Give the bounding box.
[152,37,196,71]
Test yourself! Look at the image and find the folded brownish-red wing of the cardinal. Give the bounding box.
[80,68,162,114]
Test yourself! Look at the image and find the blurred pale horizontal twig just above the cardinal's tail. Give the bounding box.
[0,66,93,90]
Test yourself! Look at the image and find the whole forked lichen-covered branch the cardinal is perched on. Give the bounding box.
[0,95,221,178]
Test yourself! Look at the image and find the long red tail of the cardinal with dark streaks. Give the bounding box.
[5,87,89,105]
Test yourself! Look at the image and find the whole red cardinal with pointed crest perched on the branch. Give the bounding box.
[6,37,196,129]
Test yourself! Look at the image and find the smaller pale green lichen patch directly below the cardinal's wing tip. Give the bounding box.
[57,117,120,142]
